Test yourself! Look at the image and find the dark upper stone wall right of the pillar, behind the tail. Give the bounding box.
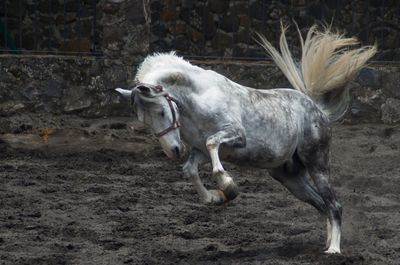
[150,0,400,61]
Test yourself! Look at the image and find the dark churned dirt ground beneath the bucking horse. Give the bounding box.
[0,112,400,265]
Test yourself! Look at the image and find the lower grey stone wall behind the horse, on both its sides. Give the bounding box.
[0,56,400,123]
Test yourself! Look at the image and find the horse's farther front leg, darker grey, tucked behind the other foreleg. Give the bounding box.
[183,149,226,205]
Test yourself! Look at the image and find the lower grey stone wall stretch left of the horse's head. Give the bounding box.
[0,56,135,117]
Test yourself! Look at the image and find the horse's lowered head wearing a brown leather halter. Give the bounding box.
[116,84,184,159]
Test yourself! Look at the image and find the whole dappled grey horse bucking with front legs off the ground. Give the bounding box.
[116,25,377,253]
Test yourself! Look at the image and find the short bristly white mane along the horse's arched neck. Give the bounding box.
[135,52,198,82]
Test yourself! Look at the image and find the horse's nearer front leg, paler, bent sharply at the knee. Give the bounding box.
[206,129,246,201]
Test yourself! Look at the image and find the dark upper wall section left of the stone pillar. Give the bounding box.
[0,0,103,53]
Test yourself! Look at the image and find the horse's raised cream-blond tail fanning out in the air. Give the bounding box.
[257,24,377,121]
